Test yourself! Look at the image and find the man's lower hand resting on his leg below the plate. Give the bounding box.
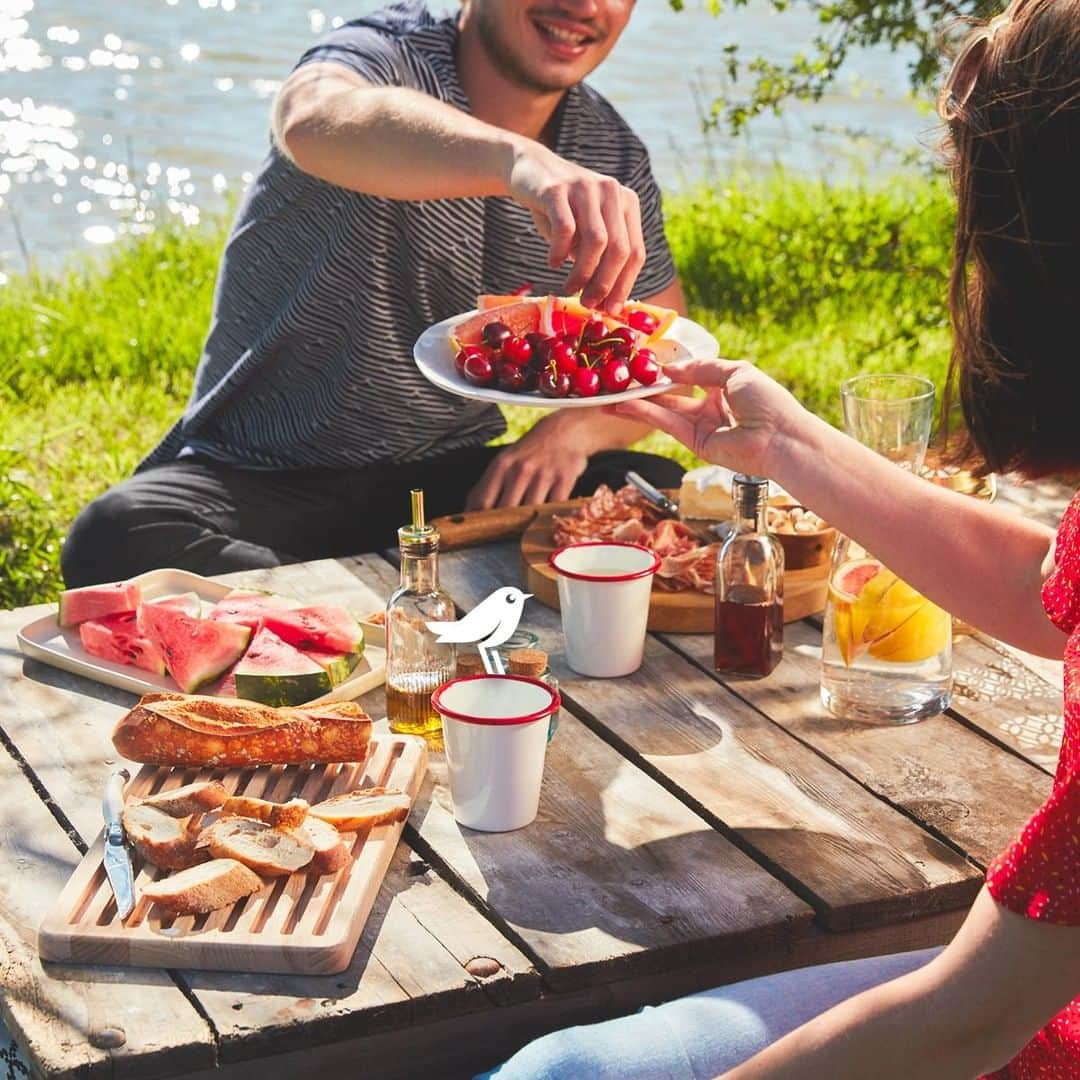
[465,417,589,510]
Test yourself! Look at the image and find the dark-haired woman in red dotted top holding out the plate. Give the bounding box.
[492,0,1080,1080]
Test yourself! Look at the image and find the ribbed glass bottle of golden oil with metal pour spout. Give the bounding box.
[387,488,457,744]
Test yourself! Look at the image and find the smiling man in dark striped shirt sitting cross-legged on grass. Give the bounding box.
[63,0,684,586]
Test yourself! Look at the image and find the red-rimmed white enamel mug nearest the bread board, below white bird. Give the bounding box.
[431,675,559,833]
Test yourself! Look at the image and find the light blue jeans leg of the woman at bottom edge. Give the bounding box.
[477,948,941,1080]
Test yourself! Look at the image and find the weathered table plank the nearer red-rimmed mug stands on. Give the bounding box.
[336,552,811,988]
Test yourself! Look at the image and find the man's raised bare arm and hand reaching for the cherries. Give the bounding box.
[273,63,645,309]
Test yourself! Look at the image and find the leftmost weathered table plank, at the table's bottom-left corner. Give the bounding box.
[0,730,216,1078]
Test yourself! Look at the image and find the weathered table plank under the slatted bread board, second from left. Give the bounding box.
[0,563,540,1075]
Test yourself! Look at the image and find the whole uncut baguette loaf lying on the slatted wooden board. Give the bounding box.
[112,693,372,768]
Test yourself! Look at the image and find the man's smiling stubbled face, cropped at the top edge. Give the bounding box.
[467,0,634,93]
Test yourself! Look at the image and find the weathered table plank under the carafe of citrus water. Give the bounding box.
[666,622,1051,866]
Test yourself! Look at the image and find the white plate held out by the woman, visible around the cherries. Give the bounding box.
[413,311,720,408]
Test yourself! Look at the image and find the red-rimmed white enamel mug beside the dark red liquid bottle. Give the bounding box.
[548,541,660,678]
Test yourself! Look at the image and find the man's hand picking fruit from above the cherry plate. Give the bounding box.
[509,139,645,311]
